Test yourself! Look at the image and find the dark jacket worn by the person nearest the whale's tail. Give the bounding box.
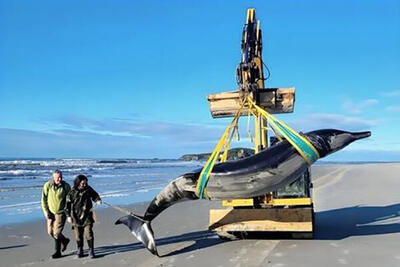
[65,185,101,226]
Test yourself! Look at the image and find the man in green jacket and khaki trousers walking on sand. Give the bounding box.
[42,170,71,259]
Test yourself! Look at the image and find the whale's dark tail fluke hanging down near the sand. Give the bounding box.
[115,214,159,257]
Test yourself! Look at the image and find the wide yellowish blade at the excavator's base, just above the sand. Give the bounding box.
[209,207,313,232]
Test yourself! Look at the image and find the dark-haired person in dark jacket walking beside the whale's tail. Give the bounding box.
[65,174,102,258]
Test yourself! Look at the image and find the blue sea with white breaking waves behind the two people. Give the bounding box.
[0,159,202,225]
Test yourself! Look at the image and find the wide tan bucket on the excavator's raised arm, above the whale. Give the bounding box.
[207,87,295,118]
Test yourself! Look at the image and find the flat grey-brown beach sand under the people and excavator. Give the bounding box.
[0,163,400,267]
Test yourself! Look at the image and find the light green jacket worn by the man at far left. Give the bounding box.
[42,180,71,218]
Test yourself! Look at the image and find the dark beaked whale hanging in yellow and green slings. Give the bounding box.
[115,129,371,255]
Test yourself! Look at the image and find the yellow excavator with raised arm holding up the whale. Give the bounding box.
[207,9,314,238]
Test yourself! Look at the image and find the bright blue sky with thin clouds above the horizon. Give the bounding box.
[0,0,400,160]
